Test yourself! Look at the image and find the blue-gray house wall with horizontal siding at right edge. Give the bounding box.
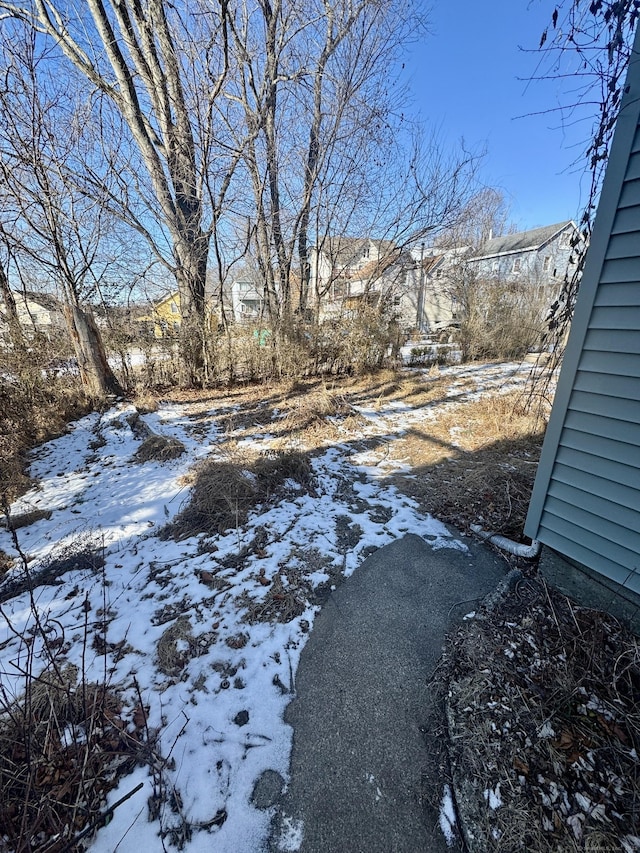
[525,26,640,612]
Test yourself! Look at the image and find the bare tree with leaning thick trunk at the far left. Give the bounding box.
[0,30,122,396]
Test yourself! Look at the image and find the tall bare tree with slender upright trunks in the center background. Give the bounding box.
[230,0,473,336]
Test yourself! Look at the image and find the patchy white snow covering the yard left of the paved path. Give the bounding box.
[0,365,544,853]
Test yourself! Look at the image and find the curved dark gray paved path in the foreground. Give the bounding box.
[272,535,507,853]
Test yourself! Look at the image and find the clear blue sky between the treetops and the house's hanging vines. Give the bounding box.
[406,0,591,229]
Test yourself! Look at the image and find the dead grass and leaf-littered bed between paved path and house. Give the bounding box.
[445,579,640,853]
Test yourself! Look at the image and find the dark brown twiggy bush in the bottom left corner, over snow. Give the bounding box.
[0,664,143,853]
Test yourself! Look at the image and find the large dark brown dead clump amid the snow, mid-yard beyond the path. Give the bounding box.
[162,451,313,540]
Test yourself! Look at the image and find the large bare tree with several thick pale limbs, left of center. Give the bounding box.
[0,0,237,379]
